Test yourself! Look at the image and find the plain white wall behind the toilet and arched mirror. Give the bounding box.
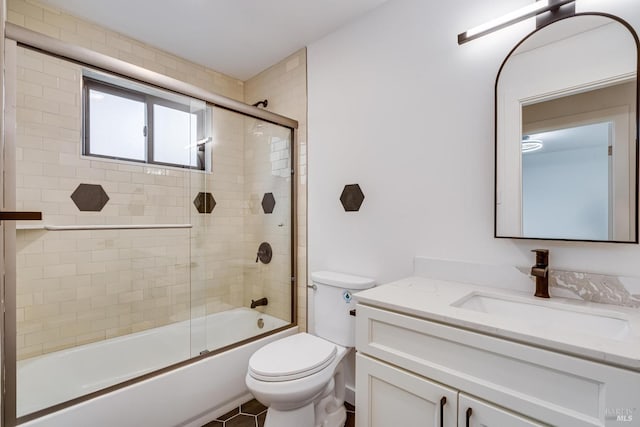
[308,0,640,288]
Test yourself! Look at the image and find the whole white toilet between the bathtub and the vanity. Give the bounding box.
[245,271,374,427]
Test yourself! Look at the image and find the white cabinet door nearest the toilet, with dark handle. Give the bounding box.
[356,353,458,427]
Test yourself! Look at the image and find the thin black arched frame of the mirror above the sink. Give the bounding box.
[493,12,640,244]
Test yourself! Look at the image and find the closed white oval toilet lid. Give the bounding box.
[249,333,337,381]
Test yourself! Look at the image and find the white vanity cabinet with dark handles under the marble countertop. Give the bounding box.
[356,304,640,427]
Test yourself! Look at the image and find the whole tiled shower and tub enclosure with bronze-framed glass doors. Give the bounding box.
[2,23,298,427]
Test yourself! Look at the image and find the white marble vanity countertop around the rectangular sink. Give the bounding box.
[354,277,640,371]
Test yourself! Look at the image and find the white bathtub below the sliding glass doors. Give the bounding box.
[16,308,297,427]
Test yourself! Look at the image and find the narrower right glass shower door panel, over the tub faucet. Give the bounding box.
[202,107,293,351]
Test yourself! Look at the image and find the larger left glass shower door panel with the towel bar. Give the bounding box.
[9,44,207,421]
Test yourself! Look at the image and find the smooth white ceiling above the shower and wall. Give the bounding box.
[43,0,386,81]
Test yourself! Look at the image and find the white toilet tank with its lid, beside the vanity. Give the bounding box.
[311,271,375,347]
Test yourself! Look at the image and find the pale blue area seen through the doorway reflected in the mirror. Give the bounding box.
[522,122,611,240]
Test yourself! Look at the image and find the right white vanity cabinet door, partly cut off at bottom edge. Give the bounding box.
[458,393,546,427]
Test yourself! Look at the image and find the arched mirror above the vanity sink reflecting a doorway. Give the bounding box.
[495,14,638,243]
